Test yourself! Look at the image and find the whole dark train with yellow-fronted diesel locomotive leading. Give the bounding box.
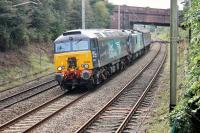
[54,29,151,90]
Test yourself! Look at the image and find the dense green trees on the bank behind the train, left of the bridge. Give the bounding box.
[0,0,113,51]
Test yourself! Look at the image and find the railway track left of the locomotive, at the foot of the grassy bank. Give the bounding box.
[0,79,58,111]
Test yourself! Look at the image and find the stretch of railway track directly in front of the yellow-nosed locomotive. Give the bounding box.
[0,42,163,132]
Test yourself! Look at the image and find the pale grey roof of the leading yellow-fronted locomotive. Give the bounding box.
[55,29,128,42]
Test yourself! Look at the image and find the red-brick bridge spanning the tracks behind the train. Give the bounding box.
[111,5,170,29]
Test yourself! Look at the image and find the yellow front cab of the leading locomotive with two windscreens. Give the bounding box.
[54,32,98,90]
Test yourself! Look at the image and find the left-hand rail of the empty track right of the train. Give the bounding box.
[76,46,161,133]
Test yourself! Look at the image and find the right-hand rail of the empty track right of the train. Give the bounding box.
[115,43,167,133]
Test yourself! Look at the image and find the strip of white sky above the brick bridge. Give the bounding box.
[108,0,182,9]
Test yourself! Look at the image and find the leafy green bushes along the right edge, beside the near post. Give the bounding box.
[171,0,200,133]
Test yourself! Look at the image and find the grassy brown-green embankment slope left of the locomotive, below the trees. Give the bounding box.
[0,45,54,92]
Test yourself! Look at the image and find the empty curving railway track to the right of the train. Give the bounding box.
[77,43,166,133]
